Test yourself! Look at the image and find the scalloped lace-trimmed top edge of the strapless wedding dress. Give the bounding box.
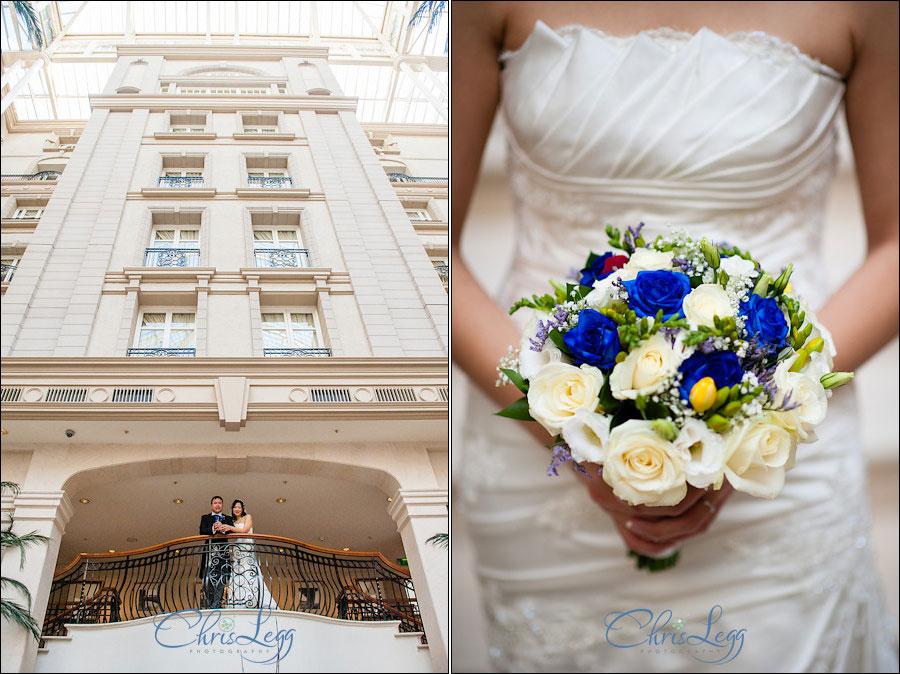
[500,19,844,82]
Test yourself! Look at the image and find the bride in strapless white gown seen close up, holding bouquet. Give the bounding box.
[452,2,898,671]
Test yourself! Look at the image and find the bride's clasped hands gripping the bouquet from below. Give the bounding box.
[585,463,734,555]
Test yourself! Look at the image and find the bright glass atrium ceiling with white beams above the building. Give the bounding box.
[0,0,449,124]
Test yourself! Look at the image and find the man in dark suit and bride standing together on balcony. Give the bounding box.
[200,496,278,608]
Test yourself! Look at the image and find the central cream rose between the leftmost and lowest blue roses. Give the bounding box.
[609,333,685,400]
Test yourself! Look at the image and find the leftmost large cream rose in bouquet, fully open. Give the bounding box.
[528,363,603,435]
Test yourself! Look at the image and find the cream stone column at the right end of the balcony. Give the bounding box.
[388,489,450,672]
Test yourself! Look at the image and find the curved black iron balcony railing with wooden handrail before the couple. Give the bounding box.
[43,534,423,637]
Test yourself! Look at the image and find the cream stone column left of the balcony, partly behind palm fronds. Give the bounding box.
[2,491,74,672]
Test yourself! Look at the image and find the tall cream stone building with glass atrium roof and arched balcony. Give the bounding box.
[0,2,449,671]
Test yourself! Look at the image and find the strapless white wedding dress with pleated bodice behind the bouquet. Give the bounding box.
[455,22,897,672]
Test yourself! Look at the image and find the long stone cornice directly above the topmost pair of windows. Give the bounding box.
[89,93,358,113]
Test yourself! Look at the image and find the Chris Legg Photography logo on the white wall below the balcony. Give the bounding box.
[153,609,296,665]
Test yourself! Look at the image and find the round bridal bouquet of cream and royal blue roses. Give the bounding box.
[498,224,853,570]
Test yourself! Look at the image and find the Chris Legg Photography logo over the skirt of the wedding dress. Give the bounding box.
[603,604,747,665]
